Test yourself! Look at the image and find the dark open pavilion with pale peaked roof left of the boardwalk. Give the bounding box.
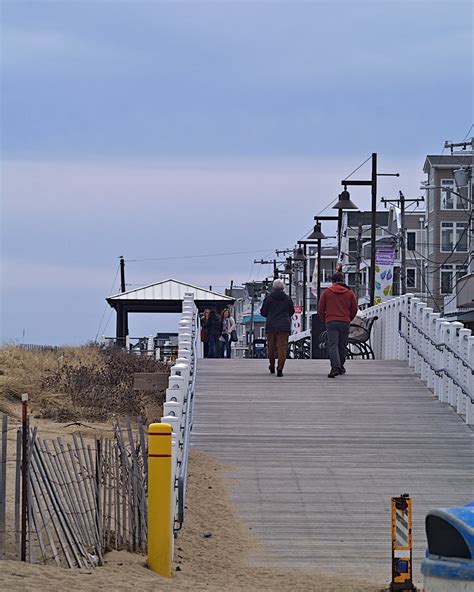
[107,279,235,343]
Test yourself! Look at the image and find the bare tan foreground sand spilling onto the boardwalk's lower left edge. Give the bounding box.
[0,451,383,592]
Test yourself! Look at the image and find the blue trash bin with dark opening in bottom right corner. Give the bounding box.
[421,502,474,592]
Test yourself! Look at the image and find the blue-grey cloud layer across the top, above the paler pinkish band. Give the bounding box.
[2,2,472,159]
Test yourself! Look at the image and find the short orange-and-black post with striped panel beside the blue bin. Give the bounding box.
[390,493,416,592]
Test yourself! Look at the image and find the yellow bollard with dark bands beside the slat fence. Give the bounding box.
[148,423,173,578]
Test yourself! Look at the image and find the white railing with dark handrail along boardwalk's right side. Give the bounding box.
[364,294,474,425]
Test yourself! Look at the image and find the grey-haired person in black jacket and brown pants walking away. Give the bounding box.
[260,279,295,376]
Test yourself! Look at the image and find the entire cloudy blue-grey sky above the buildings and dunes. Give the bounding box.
[0,0,474,345]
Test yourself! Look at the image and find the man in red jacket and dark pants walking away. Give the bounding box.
[318,271,357,378]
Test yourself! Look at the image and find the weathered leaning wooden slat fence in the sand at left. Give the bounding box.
[0,417,147,568]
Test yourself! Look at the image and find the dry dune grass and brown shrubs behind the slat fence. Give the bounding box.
[0,345,168,421]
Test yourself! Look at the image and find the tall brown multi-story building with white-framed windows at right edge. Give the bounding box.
[423,152,473,312]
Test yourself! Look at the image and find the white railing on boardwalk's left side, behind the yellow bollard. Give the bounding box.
[157,293,200,531]
